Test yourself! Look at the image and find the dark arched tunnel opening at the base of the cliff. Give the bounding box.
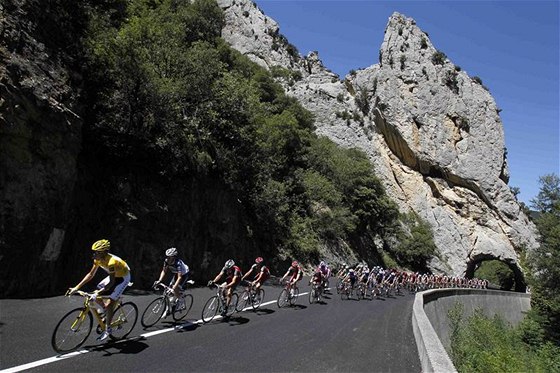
[465,255,527,293]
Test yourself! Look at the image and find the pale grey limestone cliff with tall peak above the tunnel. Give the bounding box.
[220,0,537,277]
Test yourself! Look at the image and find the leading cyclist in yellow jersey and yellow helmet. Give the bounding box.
[68,240,130,341]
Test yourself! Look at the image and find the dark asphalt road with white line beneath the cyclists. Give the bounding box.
[0,280,421,372]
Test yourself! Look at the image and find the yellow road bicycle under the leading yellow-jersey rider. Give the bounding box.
[51,290,138,353]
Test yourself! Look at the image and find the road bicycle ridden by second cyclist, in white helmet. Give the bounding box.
[140,280,194,328]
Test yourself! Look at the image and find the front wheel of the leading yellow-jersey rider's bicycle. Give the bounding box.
[51,307,93,353]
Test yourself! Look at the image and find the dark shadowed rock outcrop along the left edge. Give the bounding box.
[0,2,82,293]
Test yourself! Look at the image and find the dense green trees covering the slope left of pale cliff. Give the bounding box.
[79,0,398,258]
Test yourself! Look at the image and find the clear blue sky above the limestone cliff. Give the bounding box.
[256,0,560,204]
